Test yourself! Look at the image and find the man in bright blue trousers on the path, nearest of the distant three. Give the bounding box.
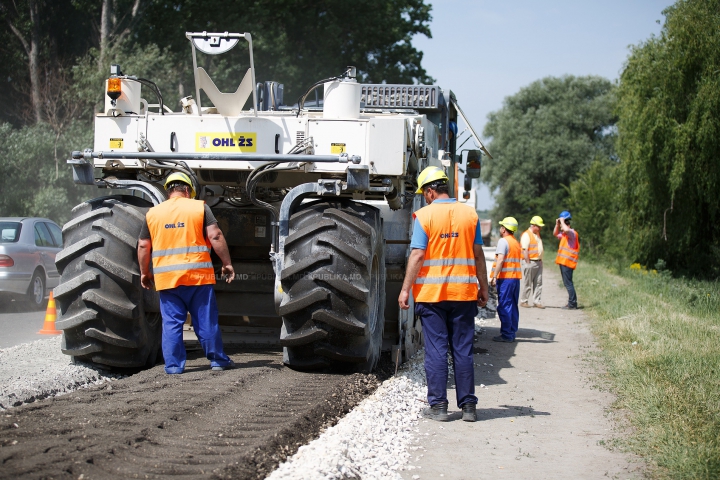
[490,217,522,343]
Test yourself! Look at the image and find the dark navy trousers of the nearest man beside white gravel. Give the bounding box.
[415,300,477,407]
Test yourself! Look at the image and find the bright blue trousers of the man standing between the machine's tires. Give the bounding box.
[159,285,230,374]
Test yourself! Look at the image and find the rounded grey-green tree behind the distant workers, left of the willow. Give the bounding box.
[483,76,616,231]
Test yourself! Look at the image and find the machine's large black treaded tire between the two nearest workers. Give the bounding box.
[279,200,385,372]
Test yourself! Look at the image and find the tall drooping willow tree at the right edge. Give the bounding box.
[618,0,720,276]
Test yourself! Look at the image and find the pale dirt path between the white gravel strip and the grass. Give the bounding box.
[402,264,642,480]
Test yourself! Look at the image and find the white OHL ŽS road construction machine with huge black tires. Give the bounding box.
[54,32,486,372]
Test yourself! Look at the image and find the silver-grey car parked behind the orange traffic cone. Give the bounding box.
[0,217,62,309]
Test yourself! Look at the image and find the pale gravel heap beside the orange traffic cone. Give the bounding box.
[0,336,123,410]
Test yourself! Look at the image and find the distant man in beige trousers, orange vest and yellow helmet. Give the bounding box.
[520,215,545,308]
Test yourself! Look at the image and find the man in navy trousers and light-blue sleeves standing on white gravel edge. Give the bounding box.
[398,167,488,422]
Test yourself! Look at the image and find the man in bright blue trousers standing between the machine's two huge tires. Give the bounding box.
[138,172,235,374]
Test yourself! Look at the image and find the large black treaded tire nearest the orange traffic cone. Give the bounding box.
[54,195,162,369]
